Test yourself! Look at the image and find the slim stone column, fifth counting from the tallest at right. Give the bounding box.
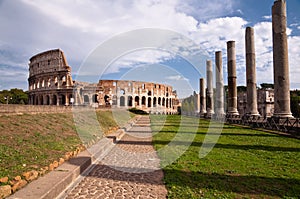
[206,60,215,117]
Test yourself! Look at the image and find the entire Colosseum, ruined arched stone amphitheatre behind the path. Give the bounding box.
[28,49,179,114]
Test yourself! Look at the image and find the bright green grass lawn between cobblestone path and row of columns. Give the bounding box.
[151,115,300,198]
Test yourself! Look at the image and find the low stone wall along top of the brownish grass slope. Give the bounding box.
[0,104,72,115]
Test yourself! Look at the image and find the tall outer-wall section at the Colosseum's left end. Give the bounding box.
[28,49,73,105]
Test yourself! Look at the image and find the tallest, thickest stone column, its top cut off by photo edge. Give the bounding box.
[272,0,292,117]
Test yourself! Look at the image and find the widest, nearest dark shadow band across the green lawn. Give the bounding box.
[164,169,300,197]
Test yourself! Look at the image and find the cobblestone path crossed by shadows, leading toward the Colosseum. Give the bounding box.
[66,116,167,199]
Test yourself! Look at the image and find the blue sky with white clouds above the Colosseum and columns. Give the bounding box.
[0,0,300,97]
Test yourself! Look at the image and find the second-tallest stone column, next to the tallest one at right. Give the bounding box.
[245,27,259,116]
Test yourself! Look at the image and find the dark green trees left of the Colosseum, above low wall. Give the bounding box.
[0,88,28,104]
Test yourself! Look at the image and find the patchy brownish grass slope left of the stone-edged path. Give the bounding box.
[0,111,133,182]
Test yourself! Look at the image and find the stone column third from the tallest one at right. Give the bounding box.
[227,41,239,115]
